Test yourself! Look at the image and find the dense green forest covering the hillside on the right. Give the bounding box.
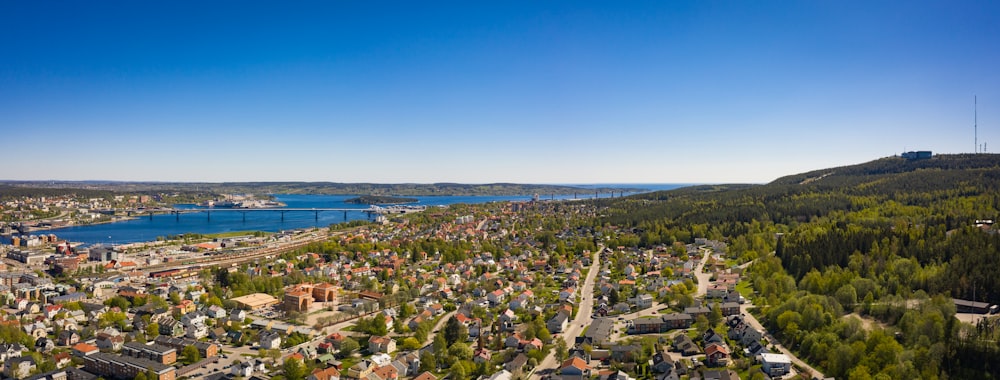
[598,154,1000,379]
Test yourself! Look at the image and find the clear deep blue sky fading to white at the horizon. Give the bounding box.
[0,1,1000,183]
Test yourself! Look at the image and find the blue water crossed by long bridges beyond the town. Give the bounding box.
[40,184,682,245]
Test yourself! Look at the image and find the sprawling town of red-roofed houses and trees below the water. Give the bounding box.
[0,193,804,380]
